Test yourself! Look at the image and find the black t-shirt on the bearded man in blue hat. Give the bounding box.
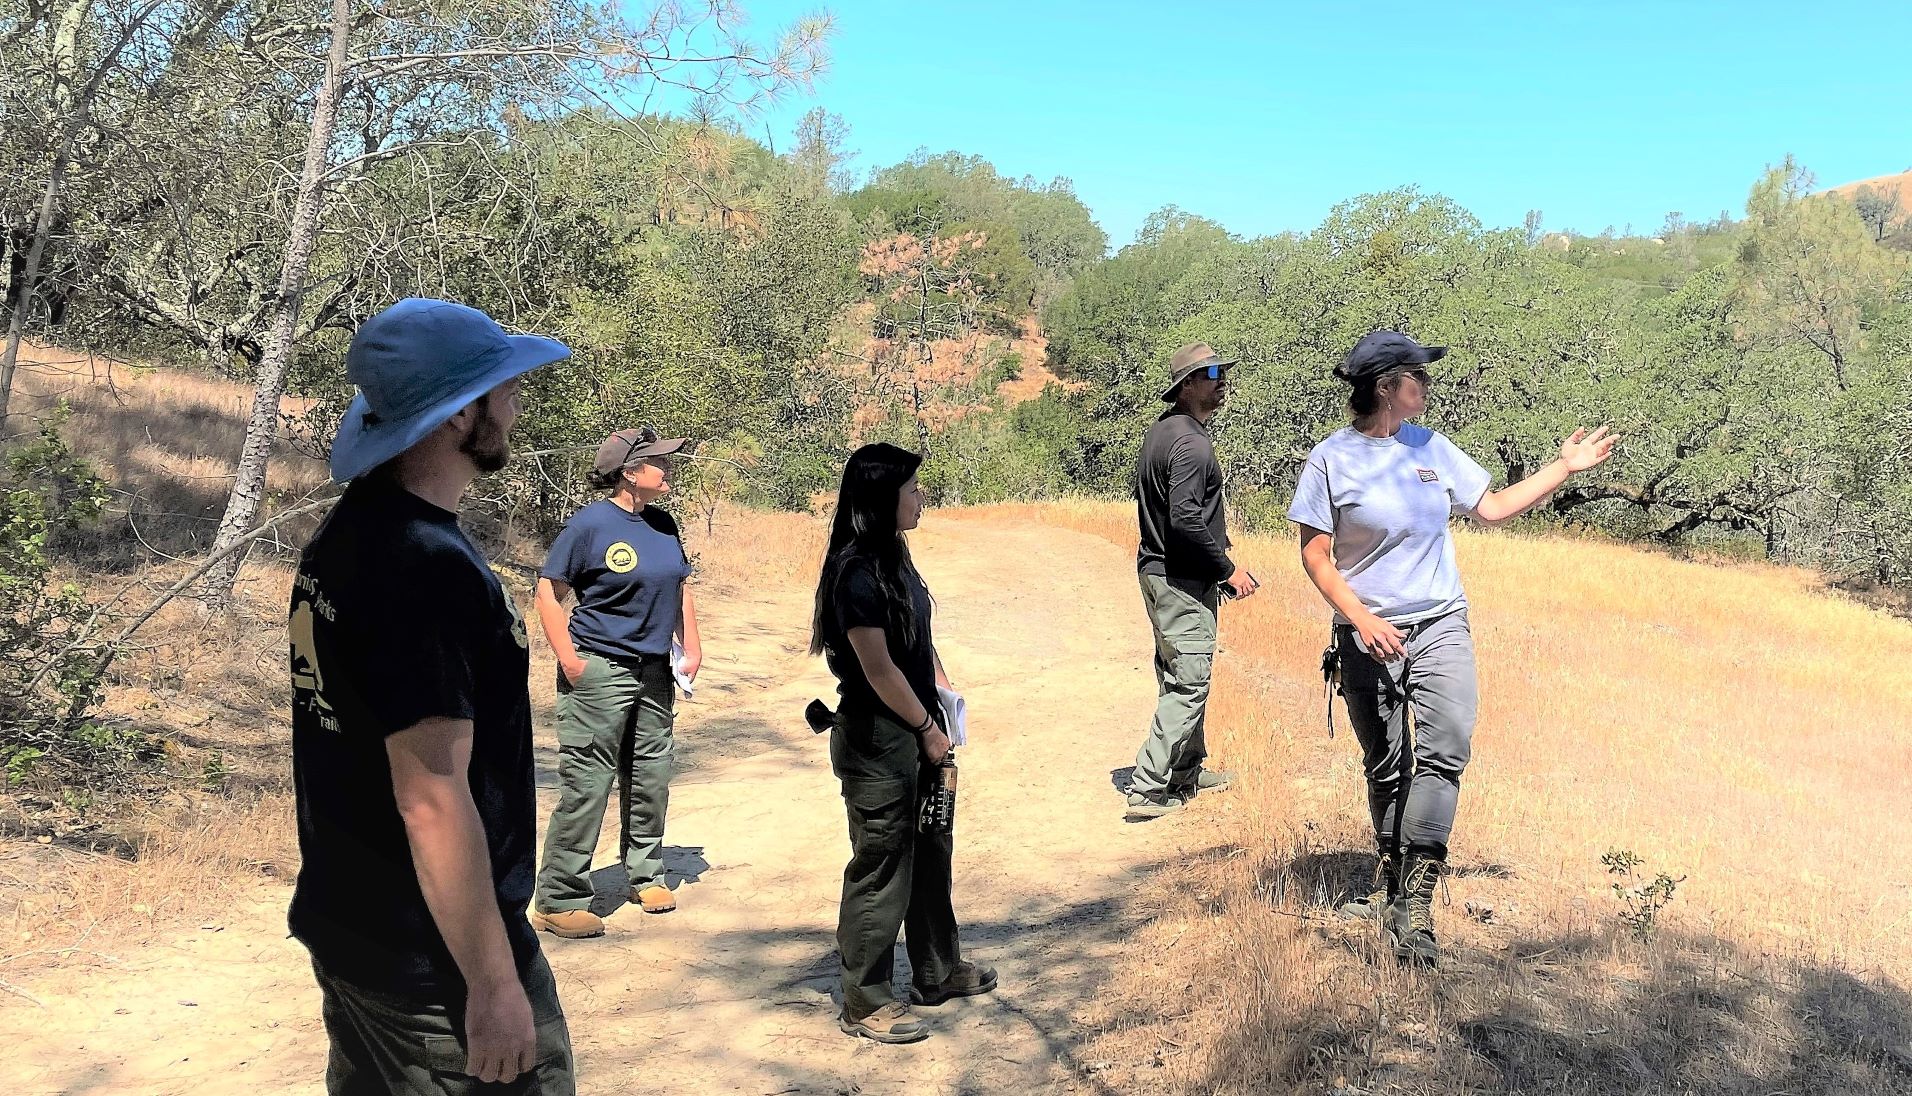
[289,474,537,995]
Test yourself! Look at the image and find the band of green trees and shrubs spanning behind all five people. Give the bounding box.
[0,0,1912,583]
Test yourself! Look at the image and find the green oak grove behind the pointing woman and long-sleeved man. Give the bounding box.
[1046,163,1912,581]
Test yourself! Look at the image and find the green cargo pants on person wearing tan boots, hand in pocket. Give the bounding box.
[537,654,677,912]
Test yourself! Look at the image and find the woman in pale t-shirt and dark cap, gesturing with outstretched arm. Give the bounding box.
[1289,331,1618,966]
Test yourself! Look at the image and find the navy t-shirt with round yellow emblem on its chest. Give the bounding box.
[539,499,690,658]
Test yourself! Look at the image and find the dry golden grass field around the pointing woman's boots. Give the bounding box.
[990,501,1912,1096]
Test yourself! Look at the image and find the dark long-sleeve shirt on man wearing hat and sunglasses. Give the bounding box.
[1136,411,1235,581]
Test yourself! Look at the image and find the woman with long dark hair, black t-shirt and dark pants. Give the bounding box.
[811,442,996,1042]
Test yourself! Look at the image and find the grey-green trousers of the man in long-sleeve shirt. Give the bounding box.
[1128,574,1222,796]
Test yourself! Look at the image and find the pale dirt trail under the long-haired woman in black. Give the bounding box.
[0,515,1206,1096]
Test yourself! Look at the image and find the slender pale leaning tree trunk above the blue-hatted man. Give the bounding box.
[201,0,352,604]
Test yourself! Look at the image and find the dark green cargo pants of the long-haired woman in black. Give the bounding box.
[830,713,962,1018]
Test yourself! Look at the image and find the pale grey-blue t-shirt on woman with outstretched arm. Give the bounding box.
[1289,423,1493,624]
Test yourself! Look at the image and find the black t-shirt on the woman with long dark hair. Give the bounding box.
[824,555,943,742]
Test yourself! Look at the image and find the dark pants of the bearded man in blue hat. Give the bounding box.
[314,954,577,1096]
